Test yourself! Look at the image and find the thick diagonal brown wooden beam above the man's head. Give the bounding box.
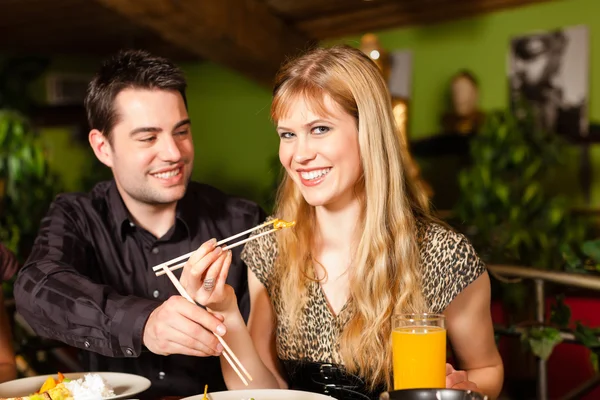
[94,0,313,86]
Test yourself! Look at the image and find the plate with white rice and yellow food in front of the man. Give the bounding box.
[0,372,150,400]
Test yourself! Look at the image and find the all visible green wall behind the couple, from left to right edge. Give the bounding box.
[35,0,600,211]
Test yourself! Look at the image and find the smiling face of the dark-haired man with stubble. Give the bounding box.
[105,89,194,205]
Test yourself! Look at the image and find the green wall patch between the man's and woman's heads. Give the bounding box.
[183,63,279,204]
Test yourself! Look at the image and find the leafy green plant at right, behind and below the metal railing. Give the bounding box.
[454,106,600,396]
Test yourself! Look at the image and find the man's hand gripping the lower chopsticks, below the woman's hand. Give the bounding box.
[143,296,226,357]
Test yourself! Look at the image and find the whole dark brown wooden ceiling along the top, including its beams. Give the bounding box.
[0,0,548,84]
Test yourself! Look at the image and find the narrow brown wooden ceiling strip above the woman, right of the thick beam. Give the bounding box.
[296,0,552,40]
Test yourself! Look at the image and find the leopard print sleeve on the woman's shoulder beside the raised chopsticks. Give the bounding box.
[242,217,277,293]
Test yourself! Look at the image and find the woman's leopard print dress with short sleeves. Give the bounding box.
[242,219,486,372]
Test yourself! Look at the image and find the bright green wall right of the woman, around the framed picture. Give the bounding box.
[331,0,600,207]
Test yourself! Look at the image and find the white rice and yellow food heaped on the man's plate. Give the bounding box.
[0,372,115,400]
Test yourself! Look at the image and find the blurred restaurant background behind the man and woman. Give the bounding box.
[0,0,600,399]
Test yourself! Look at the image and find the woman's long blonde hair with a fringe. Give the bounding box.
[271,46,429,388]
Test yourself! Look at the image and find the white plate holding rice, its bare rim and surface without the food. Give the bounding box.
[0,372,151,400]
